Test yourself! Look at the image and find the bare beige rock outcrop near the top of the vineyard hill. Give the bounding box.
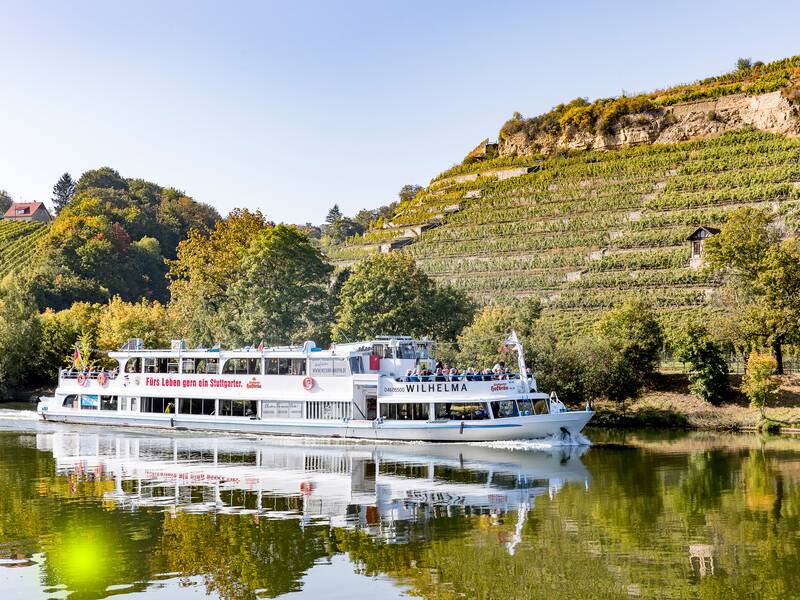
[500,92,800,155]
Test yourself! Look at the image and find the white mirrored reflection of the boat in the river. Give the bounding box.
[36,432,589,553]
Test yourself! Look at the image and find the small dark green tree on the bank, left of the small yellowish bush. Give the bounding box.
[675,322,730,406]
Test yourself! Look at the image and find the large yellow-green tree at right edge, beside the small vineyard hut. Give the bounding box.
[705,208,800,374]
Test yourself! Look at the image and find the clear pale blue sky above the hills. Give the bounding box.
[0,0,800,223]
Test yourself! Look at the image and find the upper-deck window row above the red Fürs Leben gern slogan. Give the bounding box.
[125,356,362,377]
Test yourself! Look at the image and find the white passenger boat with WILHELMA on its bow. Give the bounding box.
[37,334,593,442]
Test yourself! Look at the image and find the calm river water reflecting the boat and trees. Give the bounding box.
[0,409,800,600]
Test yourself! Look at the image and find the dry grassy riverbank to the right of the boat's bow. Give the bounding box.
[591,374,800,432]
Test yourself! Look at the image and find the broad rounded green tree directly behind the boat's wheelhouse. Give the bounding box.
[334,252,474,341]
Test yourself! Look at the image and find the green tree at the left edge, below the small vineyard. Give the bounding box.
[0,275,41,396]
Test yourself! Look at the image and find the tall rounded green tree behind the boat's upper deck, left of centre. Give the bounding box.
[222,225,333,345]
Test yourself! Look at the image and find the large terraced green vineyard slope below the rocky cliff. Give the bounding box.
[330,130,800,330]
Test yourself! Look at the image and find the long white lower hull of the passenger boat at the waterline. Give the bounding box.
[39,409,594,442]
